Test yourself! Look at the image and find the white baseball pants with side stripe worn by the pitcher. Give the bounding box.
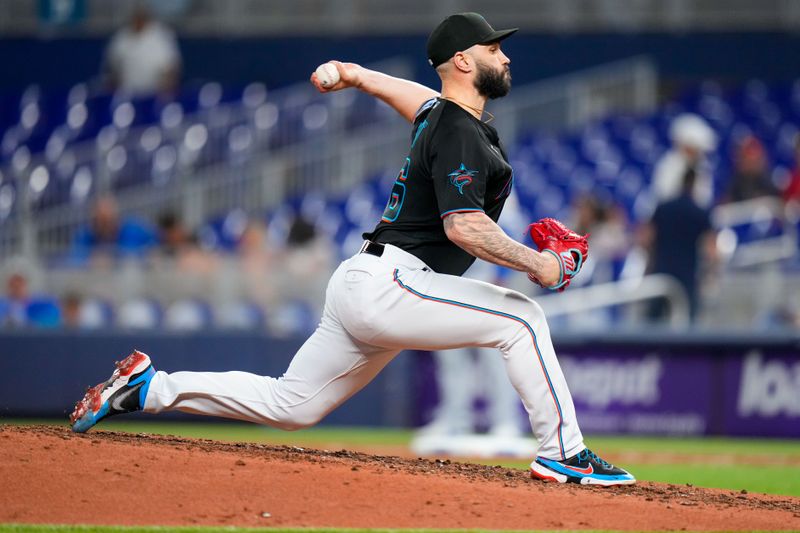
[144,245,584,459]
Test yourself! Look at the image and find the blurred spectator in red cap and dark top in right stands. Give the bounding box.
[725,135,780,202]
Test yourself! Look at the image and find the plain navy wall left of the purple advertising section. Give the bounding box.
[0,331,411,426]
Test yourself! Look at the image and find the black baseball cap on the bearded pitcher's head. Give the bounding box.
[428,13,519,68]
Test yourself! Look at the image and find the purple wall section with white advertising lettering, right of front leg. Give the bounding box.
[560,335,800,437]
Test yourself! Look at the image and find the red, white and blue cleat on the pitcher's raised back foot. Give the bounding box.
[69,350,156,433]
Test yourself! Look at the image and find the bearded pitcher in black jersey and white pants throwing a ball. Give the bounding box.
[71,13,635,485]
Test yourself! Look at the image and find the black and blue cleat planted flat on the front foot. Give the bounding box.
[531,448,636,486]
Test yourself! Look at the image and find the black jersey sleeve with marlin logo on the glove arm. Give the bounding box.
[431,126,488,218]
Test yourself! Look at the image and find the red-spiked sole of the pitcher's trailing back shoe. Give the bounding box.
[69,350,155,433]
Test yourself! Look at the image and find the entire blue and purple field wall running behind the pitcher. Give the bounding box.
[0,332,800,438]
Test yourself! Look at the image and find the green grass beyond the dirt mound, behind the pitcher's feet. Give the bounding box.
[6,419,800,497]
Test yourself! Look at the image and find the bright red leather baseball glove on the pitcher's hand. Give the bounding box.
[528,218,589,292]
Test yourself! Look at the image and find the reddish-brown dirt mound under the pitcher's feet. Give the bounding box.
[0,426,800,530]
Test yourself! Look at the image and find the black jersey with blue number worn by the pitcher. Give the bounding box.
[364,98,513,276]
